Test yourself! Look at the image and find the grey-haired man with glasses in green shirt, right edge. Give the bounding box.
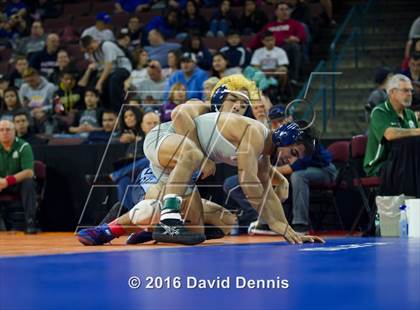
[363,74,420,176]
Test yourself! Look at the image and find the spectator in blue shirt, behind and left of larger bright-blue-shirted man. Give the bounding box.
[144,29,181,68]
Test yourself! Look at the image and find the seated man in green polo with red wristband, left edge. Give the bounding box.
[0,121,37,234]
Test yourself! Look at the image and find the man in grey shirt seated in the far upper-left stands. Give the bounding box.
[16,21,47,58]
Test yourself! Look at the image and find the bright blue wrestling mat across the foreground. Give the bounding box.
[0,238,420,310]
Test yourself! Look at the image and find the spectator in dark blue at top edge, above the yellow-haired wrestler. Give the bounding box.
[207,0,238,37]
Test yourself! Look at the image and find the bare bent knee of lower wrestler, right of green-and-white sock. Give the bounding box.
[203,200,238,235]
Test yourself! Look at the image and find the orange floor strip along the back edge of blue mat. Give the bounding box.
[0,232,294,256]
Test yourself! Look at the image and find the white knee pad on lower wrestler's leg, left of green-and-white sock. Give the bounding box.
[128,199,160,225]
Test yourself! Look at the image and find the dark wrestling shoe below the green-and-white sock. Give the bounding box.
[153,220,206,245]
